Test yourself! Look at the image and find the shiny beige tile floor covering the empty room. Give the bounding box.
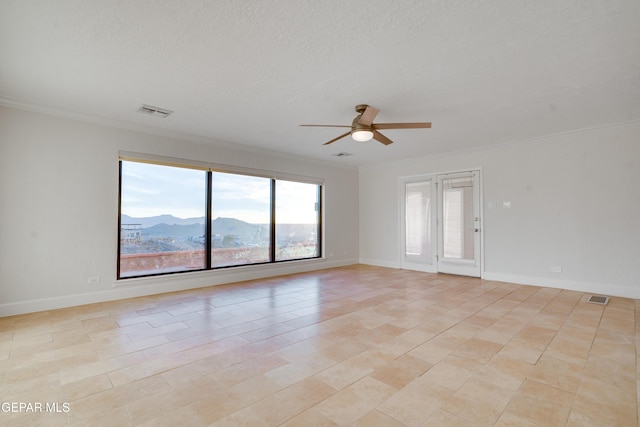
[0,265,640,427]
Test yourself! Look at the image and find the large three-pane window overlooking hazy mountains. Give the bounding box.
[118,160,322,278]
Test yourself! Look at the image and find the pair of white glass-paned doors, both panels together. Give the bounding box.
[399,171,481,277]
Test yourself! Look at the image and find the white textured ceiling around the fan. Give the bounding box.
[0,0,640,165]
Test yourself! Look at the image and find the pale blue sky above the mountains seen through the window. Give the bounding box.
[121,161,316,224]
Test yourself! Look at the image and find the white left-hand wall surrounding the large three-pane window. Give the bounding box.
[0,107,358,316]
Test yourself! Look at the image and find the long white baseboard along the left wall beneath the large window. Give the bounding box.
[0,258,358,317]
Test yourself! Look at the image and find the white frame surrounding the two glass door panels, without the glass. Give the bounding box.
[398,167,485,278]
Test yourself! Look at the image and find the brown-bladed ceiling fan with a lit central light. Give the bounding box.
[300,104,431,145]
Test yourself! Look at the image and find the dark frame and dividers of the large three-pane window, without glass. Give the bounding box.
[116,152,324,280]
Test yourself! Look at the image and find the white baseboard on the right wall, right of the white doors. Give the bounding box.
[482,272,640,299]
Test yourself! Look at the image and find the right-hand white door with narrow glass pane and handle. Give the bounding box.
[437,171,480,277]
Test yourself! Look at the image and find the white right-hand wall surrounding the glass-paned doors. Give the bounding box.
[359,122,640,298]
